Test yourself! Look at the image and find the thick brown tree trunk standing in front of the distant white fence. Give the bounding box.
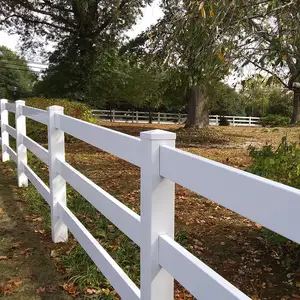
[185,87,209,128]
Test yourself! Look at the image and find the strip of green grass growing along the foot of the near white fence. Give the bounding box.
[17,152,140,300]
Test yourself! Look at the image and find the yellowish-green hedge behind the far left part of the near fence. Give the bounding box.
[9,98,95,143]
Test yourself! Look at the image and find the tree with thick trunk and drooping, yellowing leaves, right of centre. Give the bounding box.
[123,0,243,128]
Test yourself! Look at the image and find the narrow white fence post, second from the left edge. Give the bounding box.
[15,100,28,187]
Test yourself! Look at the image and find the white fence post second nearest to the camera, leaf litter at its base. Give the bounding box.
[47,106,68,243]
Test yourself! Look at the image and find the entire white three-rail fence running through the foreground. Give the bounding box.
[0,99,300,300]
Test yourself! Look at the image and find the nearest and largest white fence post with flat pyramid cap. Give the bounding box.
[140,130,176,300]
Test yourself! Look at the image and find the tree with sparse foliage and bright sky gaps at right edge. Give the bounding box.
[237,0,300,123]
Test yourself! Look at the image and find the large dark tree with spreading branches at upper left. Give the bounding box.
[0,0,151,98]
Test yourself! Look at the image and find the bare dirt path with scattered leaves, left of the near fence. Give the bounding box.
[0,162,72,300]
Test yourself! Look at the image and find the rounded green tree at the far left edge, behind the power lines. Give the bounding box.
[0,46,37,99]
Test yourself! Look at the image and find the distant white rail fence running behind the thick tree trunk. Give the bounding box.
[92,110,260,126]
